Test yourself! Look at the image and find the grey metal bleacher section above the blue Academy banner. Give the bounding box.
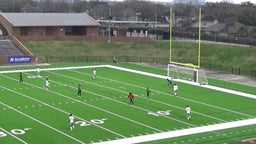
[0,40,24,56]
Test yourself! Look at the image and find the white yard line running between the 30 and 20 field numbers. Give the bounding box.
[0,100,84,144]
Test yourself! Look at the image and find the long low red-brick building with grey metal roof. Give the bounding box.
[0,13,100,40]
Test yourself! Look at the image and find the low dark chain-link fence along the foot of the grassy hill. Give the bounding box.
[42,56,256,78]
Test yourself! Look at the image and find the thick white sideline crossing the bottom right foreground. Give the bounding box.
[94,118,256,144]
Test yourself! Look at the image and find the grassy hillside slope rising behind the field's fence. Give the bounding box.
[23,41,256,69]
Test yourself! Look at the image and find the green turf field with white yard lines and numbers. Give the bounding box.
[0,65,256,144]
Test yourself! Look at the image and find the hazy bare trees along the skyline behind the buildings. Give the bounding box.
[0,0,256,38]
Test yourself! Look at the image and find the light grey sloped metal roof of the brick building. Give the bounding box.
[0,13,100,27]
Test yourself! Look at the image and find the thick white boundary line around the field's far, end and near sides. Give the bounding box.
[0,65,256,144]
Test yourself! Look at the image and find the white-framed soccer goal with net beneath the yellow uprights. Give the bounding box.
[167,64,208,84]
